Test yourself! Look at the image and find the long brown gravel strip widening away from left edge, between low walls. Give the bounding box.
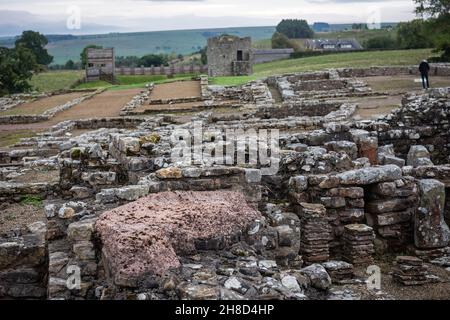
[0,89,141,132]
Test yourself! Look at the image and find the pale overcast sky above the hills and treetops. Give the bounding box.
[0,0,414,34]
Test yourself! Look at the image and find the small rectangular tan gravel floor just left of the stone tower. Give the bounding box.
[150,81,201,100]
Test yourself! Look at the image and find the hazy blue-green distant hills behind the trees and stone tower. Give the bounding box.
[0,24,398,64]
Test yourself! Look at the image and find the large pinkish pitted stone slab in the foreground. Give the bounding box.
[96,191,260,287]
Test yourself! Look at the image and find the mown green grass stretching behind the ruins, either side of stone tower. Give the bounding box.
[31,49,432,91]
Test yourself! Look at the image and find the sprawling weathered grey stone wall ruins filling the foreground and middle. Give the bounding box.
[0,65,450,300]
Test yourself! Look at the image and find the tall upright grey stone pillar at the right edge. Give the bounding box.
[414,179,450,249]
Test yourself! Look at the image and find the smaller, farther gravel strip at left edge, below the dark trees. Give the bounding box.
[0,92,84,116]
